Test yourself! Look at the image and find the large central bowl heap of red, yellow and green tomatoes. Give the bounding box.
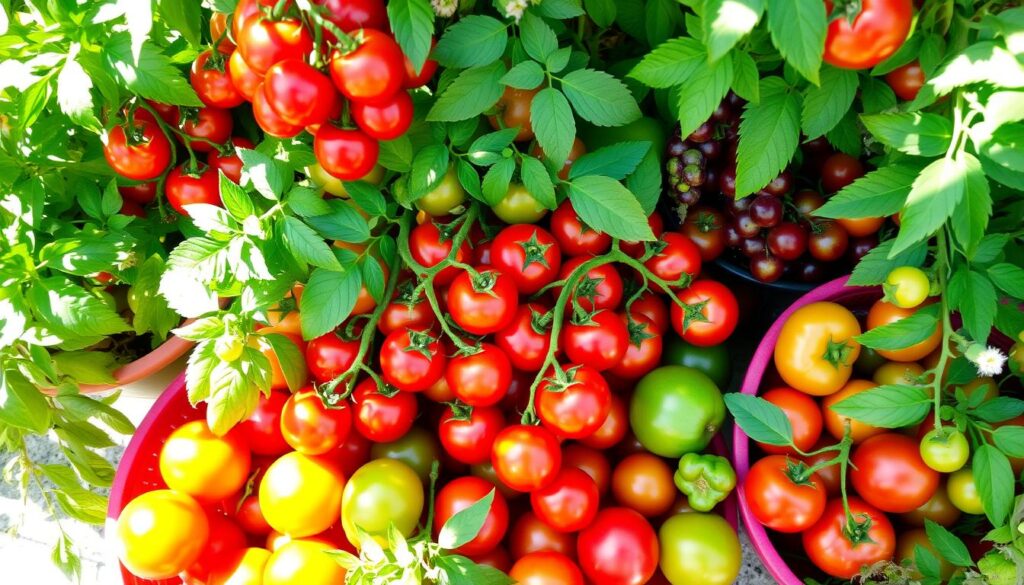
[112,196,753,585]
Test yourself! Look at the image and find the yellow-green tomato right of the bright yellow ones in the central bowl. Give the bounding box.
[341,459,423,544]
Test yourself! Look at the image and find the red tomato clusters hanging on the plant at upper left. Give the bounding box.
[103,0,423,216]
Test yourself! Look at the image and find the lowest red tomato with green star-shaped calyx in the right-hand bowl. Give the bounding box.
[803,497,896,579]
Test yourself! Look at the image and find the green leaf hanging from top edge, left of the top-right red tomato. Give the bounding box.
[767,0,827,85]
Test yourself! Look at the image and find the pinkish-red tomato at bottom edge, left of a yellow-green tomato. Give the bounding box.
[577,508,658,585]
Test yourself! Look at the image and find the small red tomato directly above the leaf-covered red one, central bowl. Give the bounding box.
[437,407,505,465]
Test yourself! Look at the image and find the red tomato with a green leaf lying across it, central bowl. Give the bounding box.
[434,475,509,555]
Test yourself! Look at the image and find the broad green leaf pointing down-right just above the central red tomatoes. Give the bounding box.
[569,175,654,242]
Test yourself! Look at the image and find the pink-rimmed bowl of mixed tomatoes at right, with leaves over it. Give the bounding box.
[729,276,1024,585]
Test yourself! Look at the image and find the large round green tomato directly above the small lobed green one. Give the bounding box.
[630,366,725,458]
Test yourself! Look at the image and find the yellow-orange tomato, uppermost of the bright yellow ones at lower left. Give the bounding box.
[160,420,251,502]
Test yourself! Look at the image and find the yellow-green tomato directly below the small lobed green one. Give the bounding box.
[657,512,741,585]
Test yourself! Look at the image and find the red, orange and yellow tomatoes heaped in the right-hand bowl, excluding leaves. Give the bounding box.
[743,293,1024,579]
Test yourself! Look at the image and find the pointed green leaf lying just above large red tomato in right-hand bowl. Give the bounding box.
[831,385,932,428]
